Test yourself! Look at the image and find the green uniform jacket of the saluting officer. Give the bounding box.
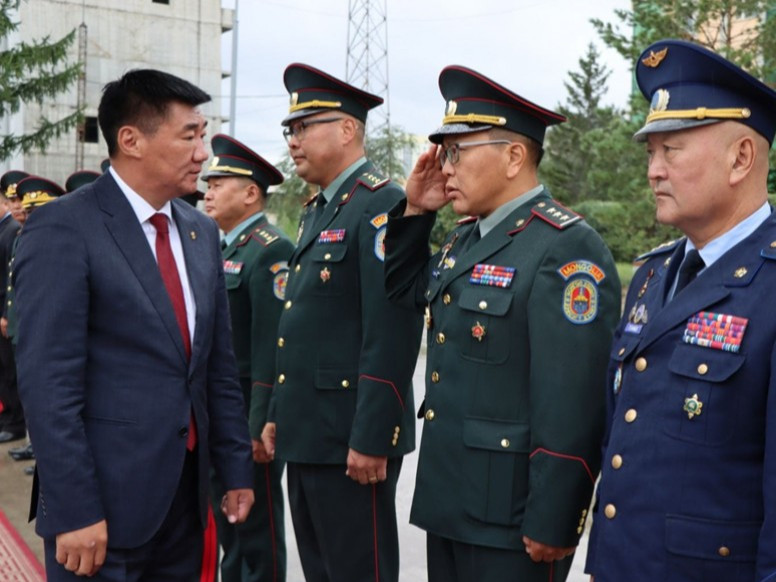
[385,190,621,556]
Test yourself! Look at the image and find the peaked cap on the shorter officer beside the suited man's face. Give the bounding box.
[202,133,283,195]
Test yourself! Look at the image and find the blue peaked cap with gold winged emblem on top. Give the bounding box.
[634,39,776,143]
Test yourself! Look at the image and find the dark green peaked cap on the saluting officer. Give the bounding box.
[429,65,566,144]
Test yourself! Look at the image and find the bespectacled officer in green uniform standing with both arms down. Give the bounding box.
[262,64,421,582]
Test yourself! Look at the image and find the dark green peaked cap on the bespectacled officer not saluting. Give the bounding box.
[281,63,383,125]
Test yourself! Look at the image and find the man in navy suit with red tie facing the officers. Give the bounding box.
[14,70,253,582]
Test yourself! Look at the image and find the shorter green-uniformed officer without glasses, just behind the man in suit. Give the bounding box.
[204,134,294,582]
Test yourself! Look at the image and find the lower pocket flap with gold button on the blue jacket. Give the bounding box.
[666,515,760,562]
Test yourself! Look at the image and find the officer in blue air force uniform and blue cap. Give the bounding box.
[587,40,776,582]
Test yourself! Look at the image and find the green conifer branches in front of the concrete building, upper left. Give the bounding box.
[0,0,81,160]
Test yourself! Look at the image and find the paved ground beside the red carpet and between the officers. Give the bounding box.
[0,354,589,582]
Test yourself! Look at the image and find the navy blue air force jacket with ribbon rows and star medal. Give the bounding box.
[587,214,776,582]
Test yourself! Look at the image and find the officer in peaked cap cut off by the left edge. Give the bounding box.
[0,170,22,443]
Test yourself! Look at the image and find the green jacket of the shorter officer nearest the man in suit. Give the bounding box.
[223,215,294,440]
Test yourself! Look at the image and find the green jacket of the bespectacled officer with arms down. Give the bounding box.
[270,162,422,465]
